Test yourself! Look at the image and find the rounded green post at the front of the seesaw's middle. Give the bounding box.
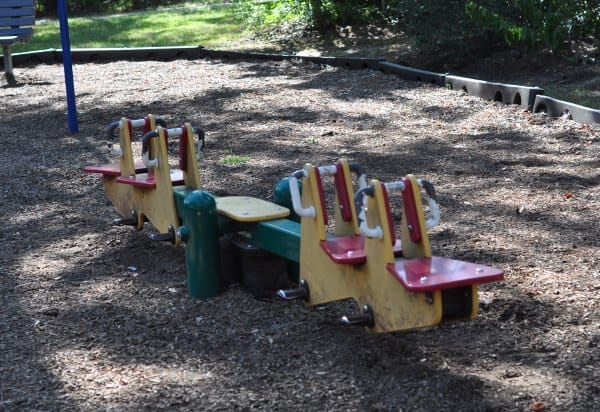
[176,190,223,299]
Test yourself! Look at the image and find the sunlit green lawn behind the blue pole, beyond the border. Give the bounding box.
[12,5,244,53]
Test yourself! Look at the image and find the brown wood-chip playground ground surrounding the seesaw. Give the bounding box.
[0,60,600,411]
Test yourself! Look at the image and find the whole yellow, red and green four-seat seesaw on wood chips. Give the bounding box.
[86,116,503,333]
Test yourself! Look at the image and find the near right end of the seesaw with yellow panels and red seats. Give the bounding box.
[279,165,503,332]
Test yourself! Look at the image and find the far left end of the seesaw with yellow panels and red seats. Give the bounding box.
[84,115,204,244]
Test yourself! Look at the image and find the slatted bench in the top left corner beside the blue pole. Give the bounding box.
[0,0,35,81]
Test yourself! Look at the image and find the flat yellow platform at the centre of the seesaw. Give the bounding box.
[217,196,290,222]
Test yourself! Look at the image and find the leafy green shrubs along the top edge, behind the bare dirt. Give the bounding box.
[236,0,600,59]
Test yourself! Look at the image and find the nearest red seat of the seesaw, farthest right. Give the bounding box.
[387,256,504,292]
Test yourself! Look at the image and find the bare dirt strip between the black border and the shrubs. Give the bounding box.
[245,26,600,109]
